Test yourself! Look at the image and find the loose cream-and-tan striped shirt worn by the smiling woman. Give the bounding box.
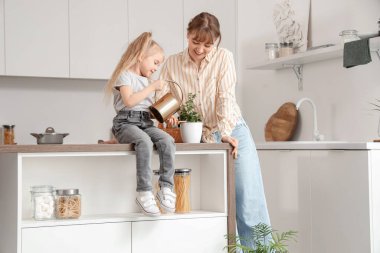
[158,48,241,142]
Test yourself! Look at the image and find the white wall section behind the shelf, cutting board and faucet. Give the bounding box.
[237,0,380,141]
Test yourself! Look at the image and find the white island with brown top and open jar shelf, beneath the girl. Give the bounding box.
[0,144,235,253]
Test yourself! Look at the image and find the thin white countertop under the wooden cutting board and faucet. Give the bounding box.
[256,141,380,150]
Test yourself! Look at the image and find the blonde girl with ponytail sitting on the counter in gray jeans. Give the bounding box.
[106,32,176,216]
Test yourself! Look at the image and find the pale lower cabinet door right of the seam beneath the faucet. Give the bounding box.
[311,150,371,252]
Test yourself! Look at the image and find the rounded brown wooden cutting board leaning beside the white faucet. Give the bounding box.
[265,102,298,141]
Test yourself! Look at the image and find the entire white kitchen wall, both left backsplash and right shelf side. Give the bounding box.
[0,0,380,144]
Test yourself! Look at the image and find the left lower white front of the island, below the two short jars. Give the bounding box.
[22,222,131,253]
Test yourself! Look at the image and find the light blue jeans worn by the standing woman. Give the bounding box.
[214,119,270,248]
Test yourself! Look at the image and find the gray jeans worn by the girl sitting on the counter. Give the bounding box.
[112,110,175,192]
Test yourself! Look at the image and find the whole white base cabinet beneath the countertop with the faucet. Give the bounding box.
[259,150,380,253]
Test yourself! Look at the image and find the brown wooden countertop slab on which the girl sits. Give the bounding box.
[0,143,230,153]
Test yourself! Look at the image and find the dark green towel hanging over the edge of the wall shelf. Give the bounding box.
[343,38,372,68]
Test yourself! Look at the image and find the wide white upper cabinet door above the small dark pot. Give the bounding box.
[5,0,69,77]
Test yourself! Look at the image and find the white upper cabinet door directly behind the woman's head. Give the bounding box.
[184,0,237,55]
